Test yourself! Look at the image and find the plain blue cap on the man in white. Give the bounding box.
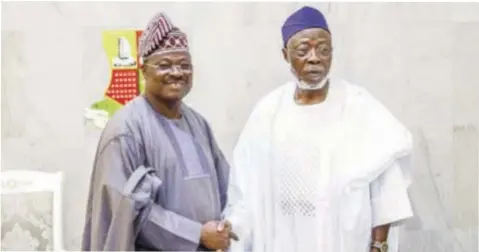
[281,6,330,47]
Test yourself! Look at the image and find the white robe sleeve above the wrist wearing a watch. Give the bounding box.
[371,156,413,252]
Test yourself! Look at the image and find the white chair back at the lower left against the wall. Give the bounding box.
[0,170,63,251]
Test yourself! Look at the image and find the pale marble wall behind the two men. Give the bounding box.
[1,2,479,252]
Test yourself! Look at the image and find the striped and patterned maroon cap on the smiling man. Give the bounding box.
[138,12,188,58]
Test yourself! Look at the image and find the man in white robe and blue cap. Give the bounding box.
[226,7,413,252]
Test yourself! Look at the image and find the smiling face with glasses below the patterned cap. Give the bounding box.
[142,52,193,102]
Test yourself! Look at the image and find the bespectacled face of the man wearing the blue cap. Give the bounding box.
[283,28,332,85]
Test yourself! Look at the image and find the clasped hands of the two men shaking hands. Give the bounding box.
[200,220,239,251]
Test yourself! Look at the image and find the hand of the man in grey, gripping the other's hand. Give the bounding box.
[200,221,230,250]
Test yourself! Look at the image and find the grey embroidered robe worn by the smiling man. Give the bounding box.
[82,12,229,251]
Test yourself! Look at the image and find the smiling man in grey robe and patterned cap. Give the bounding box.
[82,13,234,251]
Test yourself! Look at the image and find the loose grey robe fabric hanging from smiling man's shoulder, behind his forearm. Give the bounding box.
[82,134,148,251]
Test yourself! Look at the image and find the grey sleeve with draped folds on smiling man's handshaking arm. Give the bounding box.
[83,135,201,251]
